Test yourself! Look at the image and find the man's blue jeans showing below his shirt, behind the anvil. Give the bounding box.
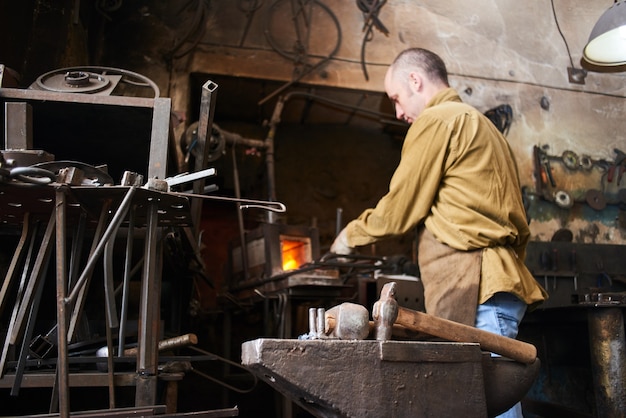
[476,293,526,418]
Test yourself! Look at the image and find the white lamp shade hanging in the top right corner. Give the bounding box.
[583,1,626,67]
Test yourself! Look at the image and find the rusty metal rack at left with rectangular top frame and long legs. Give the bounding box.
[0,88,184,417]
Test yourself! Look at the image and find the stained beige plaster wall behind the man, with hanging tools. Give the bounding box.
[157,0,626,243]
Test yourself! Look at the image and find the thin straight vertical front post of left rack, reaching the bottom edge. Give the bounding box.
[55,188,70,418]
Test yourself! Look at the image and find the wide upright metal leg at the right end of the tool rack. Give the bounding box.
[135,199,162,406]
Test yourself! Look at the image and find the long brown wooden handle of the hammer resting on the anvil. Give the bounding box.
[395,307,537,364]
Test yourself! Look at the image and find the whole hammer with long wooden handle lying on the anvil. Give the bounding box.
[372,282,537,364]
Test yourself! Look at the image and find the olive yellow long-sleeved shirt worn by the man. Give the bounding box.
[346,88,547,305]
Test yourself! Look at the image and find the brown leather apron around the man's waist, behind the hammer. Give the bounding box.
[417,227,482,326]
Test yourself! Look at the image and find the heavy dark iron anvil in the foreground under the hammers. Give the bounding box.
[242,339,538,418]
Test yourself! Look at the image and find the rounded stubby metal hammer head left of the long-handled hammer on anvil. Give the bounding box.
[324,302,370,340]
